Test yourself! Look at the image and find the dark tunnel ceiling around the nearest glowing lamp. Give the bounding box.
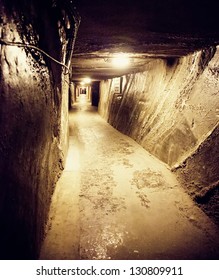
[72,0,219,81]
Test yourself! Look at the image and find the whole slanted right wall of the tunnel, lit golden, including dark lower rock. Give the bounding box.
[99,47,219,221]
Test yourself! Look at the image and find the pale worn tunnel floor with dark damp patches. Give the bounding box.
[40,95,219,260]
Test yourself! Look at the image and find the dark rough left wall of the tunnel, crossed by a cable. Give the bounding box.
[0,0,75,259]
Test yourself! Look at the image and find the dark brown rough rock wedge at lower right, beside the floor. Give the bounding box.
[174,126,219,225]
